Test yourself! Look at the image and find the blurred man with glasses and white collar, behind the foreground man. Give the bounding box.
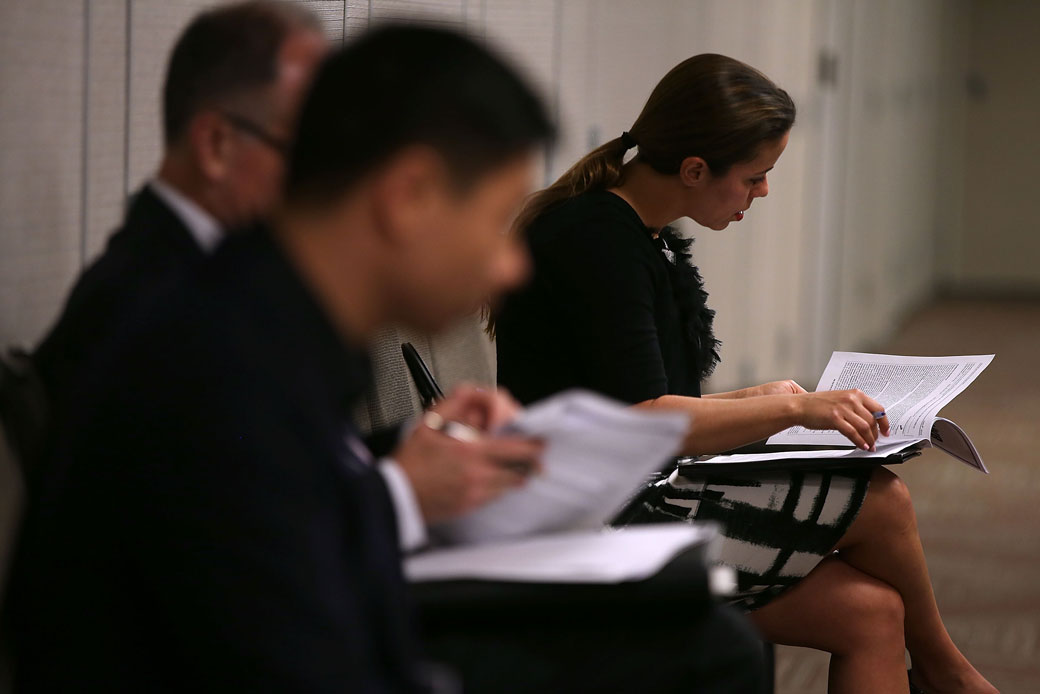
[34,0,327,406]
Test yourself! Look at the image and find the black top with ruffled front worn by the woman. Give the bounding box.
[496,190,719,404]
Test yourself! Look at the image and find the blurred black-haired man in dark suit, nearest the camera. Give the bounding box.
[12,27,759,692]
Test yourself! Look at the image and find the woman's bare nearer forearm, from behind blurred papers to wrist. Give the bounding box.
[635,395,798,456]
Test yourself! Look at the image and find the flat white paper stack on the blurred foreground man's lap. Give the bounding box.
[405,523,718,584]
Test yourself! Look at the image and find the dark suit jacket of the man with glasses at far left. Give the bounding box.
[33,186,205,407]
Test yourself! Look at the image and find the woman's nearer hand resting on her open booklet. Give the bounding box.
[795,390,889,451]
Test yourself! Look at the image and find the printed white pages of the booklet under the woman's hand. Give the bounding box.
[768,352,993,445]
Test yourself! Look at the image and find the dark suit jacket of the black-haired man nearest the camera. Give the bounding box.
[12,232,424,692]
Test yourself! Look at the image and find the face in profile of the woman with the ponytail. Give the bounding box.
[688,133,789,231]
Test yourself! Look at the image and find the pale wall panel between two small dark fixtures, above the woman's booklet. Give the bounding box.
[837,0,951,348]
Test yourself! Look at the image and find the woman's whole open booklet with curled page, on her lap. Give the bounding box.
[698,352,993,472]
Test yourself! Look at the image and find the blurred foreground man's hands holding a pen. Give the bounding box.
[393,386,544,523]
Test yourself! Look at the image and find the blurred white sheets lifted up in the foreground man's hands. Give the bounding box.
[434,390,690,544]
